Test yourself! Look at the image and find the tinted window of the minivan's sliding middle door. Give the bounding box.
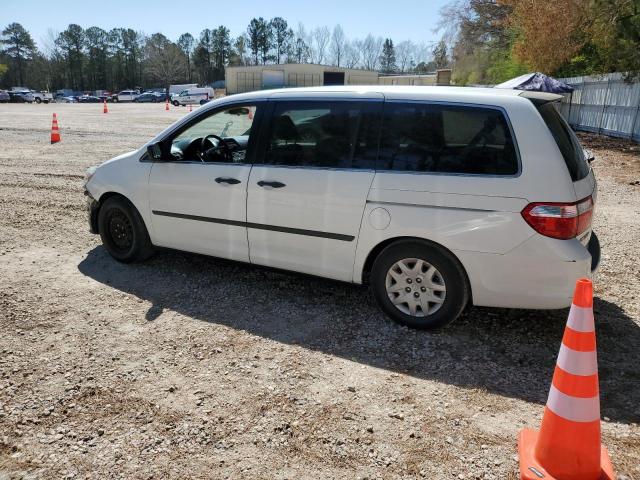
[264,101,380,169]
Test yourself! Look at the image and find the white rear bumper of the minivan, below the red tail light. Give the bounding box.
[455,234,600,309]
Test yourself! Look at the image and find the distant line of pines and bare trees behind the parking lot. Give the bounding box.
[0,17,449,91]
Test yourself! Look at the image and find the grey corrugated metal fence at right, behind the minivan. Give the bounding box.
[560,73,640,142]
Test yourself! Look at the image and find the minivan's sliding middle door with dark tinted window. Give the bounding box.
[247,100,381,281]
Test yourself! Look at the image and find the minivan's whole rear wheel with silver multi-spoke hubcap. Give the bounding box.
[370,240,469,330]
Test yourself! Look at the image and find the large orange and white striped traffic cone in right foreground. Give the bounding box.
[518,278,615,480]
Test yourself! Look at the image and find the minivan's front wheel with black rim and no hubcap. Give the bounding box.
[98,197,153,263]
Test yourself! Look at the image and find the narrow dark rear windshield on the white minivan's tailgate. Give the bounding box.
[537,103,589,182]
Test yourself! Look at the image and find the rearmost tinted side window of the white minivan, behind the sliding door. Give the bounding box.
[378,102,519,175]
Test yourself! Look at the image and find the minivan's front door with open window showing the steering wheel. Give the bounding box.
[149,105,258,261]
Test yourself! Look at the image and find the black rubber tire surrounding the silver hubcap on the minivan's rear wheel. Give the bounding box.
[370,240,470,330]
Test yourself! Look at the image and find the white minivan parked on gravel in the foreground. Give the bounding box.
[85,86,600,328]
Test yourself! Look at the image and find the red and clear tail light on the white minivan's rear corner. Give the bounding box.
[522,197,593,240]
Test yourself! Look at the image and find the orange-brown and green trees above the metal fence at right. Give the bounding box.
[440,0,640,85]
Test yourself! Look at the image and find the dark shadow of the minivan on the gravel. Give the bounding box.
[78,247,640,423]
